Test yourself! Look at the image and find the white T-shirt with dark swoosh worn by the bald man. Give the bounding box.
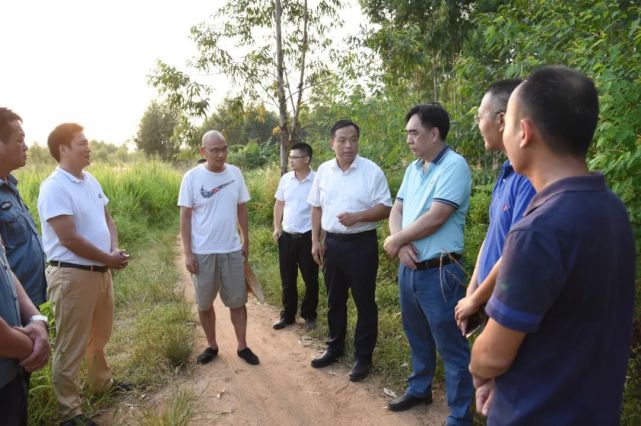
[178,164,249,254]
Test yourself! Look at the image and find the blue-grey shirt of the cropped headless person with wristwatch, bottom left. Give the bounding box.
[0,244,21,388]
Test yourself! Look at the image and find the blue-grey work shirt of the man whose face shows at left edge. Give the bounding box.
[0,175,47,307]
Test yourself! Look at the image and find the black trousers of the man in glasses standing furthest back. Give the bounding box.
[278,231,318,322]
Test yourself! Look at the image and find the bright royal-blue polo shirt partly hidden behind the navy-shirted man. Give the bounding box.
[477,161,536,284]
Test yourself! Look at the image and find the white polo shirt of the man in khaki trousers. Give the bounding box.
[38,167,111,265]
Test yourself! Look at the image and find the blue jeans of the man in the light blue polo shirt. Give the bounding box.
[398,263,474,425]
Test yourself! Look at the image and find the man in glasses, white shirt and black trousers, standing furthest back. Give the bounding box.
[273,142,318,330]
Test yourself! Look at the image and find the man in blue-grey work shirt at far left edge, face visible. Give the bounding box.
[0,108,47,306]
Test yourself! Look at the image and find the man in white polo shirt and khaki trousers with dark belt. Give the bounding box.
[38,123,131,425]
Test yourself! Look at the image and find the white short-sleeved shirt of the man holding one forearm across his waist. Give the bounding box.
[307,155,392,234]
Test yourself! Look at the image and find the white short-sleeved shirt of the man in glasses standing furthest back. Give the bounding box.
[274,170,316,234]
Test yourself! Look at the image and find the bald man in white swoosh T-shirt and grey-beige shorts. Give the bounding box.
[178,130,259,365]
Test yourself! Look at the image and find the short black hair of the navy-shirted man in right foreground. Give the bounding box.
[517,65,599,157]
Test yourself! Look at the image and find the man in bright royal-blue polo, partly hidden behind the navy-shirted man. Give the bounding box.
[454,79,535,334]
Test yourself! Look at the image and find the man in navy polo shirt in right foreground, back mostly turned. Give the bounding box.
[470,66,635,425]
